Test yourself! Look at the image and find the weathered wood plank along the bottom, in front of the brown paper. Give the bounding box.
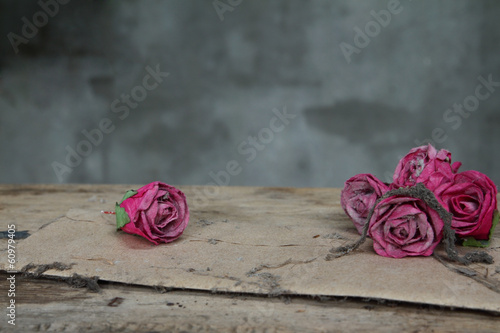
[0,274,500,332]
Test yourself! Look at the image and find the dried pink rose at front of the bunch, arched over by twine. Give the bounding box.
[368,196,444,258]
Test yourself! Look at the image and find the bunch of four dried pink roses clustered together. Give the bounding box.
[341,144,497,258]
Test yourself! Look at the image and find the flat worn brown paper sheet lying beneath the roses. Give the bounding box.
[3,187,500,312]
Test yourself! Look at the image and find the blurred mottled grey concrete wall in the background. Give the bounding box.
[0,0,500,187]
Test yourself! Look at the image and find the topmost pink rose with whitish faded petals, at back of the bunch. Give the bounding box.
[391,144,462,191]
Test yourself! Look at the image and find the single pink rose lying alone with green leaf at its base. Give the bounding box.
[115,182,189,245]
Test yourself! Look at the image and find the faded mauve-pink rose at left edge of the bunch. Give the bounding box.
[340,174,389,234]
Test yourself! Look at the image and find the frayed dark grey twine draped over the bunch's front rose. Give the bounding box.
[325,183,493,265]
